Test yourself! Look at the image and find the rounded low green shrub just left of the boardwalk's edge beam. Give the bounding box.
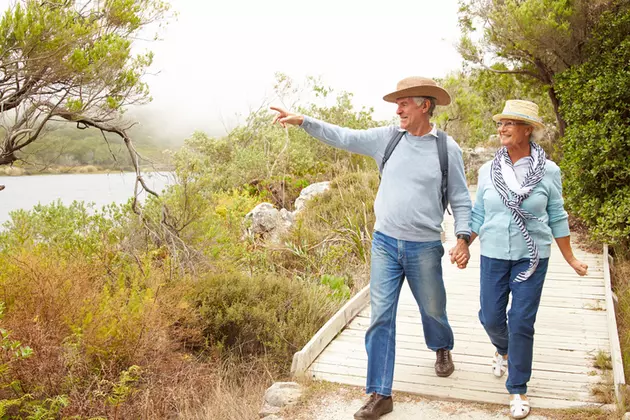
[190,272,337,369]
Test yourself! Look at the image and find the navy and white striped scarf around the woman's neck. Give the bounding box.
[490,142,546,282]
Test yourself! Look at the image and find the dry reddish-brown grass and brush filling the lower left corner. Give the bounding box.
[0,240,321,420]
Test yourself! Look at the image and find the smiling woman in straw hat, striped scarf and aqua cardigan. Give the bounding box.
[457,100,588,419]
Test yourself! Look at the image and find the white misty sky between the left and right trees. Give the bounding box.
[0,0,461,140]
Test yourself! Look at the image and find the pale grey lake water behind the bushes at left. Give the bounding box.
[0,172,172,226]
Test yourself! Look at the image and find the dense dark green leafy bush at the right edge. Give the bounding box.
[556,7,630,246]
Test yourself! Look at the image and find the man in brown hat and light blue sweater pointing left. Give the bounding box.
[271,77,472,420]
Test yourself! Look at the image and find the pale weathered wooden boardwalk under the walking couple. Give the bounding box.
[293,215,616,408]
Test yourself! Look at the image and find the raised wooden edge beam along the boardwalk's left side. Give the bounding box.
[291,285,370,376]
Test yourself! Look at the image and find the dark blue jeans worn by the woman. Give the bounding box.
[479,255,549,394]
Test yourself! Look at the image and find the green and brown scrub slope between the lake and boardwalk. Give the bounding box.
[0,74,392,418]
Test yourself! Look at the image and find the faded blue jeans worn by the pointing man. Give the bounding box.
[365,232,453,395]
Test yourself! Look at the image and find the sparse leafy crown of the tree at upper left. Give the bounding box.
[0,0,169,165]
